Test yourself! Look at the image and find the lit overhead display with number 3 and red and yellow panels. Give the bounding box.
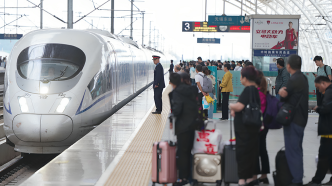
[182,21,250,33]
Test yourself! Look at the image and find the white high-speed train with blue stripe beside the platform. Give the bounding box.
[3,29,168,154]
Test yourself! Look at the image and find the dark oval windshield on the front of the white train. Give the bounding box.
[17,44,86,81]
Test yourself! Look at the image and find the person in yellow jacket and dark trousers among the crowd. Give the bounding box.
[220,64,233,120]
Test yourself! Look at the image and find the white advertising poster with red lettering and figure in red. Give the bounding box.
[252,19,299,50]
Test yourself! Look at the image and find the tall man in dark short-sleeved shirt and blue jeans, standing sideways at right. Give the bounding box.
[279,55,309,186]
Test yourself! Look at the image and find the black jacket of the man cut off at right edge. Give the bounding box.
[316,85,332,135]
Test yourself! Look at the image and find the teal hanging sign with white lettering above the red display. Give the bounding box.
[209,15,250,26]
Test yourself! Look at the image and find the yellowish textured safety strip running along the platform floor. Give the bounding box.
[105,85,172,186]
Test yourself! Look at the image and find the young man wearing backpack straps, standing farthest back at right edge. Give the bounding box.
[314,56,332,106]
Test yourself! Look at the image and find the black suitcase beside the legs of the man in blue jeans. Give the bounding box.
[273,148,293,186]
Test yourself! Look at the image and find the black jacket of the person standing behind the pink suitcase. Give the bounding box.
[169,83,198,135]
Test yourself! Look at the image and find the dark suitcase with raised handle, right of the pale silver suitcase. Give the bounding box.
[222,116,239,186]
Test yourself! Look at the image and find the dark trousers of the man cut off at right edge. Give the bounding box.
[312,138,332,184]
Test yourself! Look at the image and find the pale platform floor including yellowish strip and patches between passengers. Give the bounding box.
[21,77,330,186]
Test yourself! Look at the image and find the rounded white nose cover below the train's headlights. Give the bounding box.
[13,114,73,142]
